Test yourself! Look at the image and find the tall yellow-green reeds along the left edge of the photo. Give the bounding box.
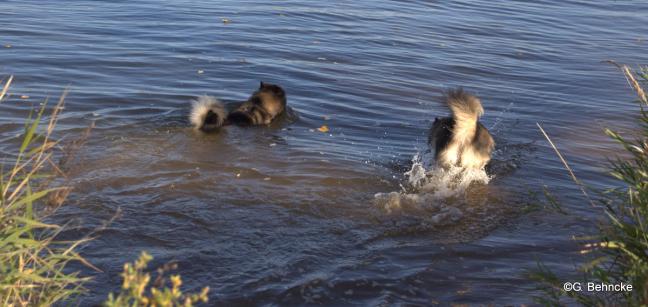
[0,77,92,306]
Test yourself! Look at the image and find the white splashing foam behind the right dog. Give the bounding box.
[374,154,491,225]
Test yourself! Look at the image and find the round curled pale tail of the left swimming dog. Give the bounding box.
[189,96,227,132]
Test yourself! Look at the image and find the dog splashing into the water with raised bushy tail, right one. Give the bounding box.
[428,88,495,169]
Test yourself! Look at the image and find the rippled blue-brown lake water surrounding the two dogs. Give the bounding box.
[0,0,648,306]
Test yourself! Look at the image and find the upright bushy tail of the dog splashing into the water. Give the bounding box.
[446,88,484,145]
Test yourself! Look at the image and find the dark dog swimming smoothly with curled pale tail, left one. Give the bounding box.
[189,81,286,132]
